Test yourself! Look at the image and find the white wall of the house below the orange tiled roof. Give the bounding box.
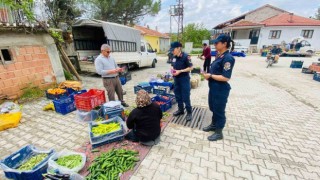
[258,27,320,51]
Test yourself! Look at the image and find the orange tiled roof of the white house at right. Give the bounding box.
[261,13,320,26]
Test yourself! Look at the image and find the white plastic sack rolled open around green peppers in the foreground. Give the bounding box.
[48,149,87,175]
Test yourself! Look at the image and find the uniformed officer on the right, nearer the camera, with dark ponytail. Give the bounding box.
[203,34,235,141]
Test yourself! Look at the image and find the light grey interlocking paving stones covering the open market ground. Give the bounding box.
[0,56,320,180]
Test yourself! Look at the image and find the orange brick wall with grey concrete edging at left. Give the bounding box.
[0,32,65,98]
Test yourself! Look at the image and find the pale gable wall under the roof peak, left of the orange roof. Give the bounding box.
[245,7,283,22]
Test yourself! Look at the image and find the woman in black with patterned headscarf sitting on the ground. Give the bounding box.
[126,90,162,146]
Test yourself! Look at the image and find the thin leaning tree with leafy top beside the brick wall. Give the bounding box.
[4,0,81,80]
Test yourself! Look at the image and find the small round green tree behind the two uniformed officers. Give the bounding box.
[182,23,211,47]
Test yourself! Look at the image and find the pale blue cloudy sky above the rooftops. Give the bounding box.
[139,0,320,33]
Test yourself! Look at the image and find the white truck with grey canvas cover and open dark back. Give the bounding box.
[72,19,157,69]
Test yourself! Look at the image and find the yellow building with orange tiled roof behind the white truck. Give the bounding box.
[134,25,170,52]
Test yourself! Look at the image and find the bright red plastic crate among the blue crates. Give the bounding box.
[74,89,106,111]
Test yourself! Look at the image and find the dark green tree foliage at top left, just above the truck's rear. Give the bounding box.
[45,0,82,28]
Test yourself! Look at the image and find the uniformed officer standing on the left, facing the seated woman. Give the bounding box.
[170,42,193,121]
